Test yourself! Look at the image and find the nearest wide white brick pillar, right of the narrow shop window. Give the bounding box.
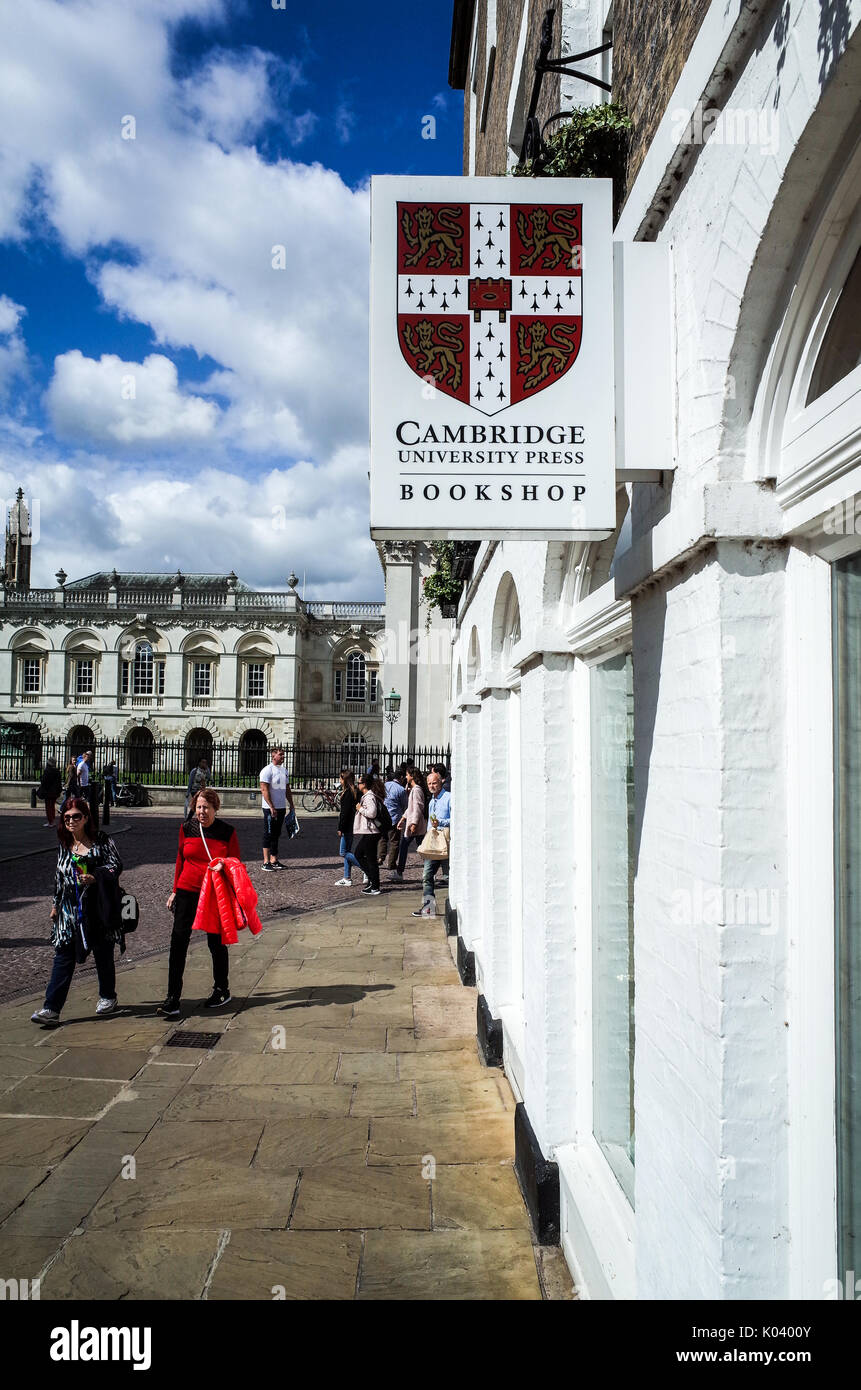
[633,541,795,1300]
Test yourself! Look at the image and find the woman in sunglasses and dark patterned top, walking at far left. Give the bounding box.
[31,796,122,1029]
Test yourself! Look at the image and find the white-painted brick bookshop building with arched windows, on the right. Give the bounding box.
[448,0,861,1300]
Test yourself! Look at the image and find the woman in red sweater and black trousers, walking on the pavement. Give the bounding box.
[157,787,241,1019]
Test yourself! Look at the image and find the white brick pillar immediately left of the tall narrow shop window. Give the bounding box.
[512,653,574,1156]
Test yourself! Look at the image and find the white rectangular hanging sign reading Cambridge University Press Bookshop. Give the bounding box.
[370,177,616,541]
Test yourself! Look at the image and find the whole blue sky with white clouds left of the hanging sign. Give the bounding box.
[0,0,462,598]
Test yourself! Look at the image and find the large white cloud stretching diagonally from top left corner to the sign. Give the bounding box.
[0,0,369,459]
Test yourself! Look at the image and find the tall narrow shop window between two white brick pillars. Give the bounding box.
[591,653,634,1204]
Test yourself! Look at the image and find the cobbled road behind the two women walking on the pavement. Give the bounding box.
[0,808,431,1001]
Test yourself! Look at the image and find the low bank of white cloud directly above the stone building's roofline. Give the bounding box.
[0,447,383,599]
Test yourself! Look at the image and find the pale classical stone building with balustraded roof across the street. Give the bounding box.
[0,499,385,760]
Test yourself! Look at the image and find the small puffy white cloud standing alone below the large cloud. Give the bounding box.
[47,348,218,446]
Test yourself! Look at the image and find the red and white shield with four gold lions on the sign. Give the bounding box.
[398,203,583,416]
